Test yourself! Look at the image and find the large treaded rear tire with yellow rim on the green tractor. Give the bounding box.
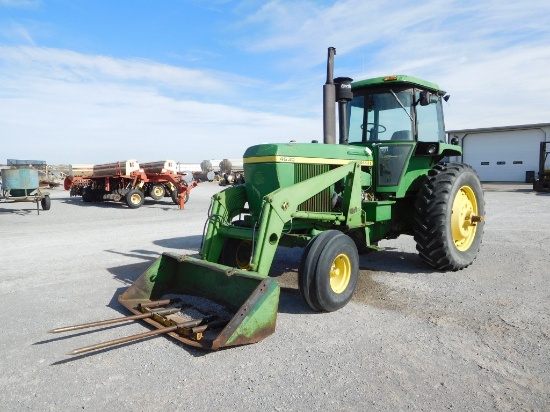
[414,163,485,271]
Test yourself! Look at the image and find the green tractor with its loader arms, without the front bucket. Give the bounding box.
[202,49,484,311]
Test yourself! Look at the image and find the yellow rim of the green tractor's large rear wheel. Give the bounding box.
[451,186,478,252]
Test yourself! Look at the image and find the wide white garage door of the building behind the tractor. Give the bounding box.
[462,129,544,182]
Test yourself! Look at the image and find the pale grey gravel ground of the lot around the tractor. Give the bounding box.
[0,183,550,411]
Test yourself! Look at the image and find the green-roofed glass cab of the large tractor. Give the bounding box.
[344,75,458,197]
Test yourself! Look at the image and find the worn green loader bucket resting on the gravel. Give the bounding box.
[118,253,280,350]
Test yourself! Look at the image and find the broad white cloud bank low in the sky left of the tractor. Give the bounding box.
[0,47,321,164]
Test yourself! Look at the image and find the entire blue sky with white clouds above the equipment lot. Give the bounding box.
[0,0,550,164]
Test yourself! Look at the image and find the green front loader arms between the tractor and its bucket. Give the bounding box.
[202,162,364,276]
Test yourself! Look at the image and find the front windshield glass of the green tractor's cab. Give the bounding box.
[348,90,413,143]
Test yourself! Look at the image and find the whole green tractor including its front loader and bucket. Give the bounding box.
[56,48,485,349]
